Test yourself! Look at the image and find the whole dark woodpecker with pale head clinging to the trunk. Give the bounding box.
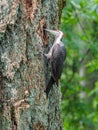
[44,29,66,97]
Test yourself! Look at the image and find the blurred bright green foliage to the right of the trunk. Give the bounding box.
[61,0,98,130]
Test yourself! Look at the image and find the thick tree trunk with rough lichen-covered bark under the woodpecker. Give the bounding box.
[0,0,65,130]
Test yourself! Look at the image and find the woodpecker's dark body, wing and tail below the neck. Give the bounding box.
[46,41,66,97]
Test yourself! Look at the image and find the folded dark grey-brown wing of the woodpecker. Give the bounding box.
[51,44,66,82]
